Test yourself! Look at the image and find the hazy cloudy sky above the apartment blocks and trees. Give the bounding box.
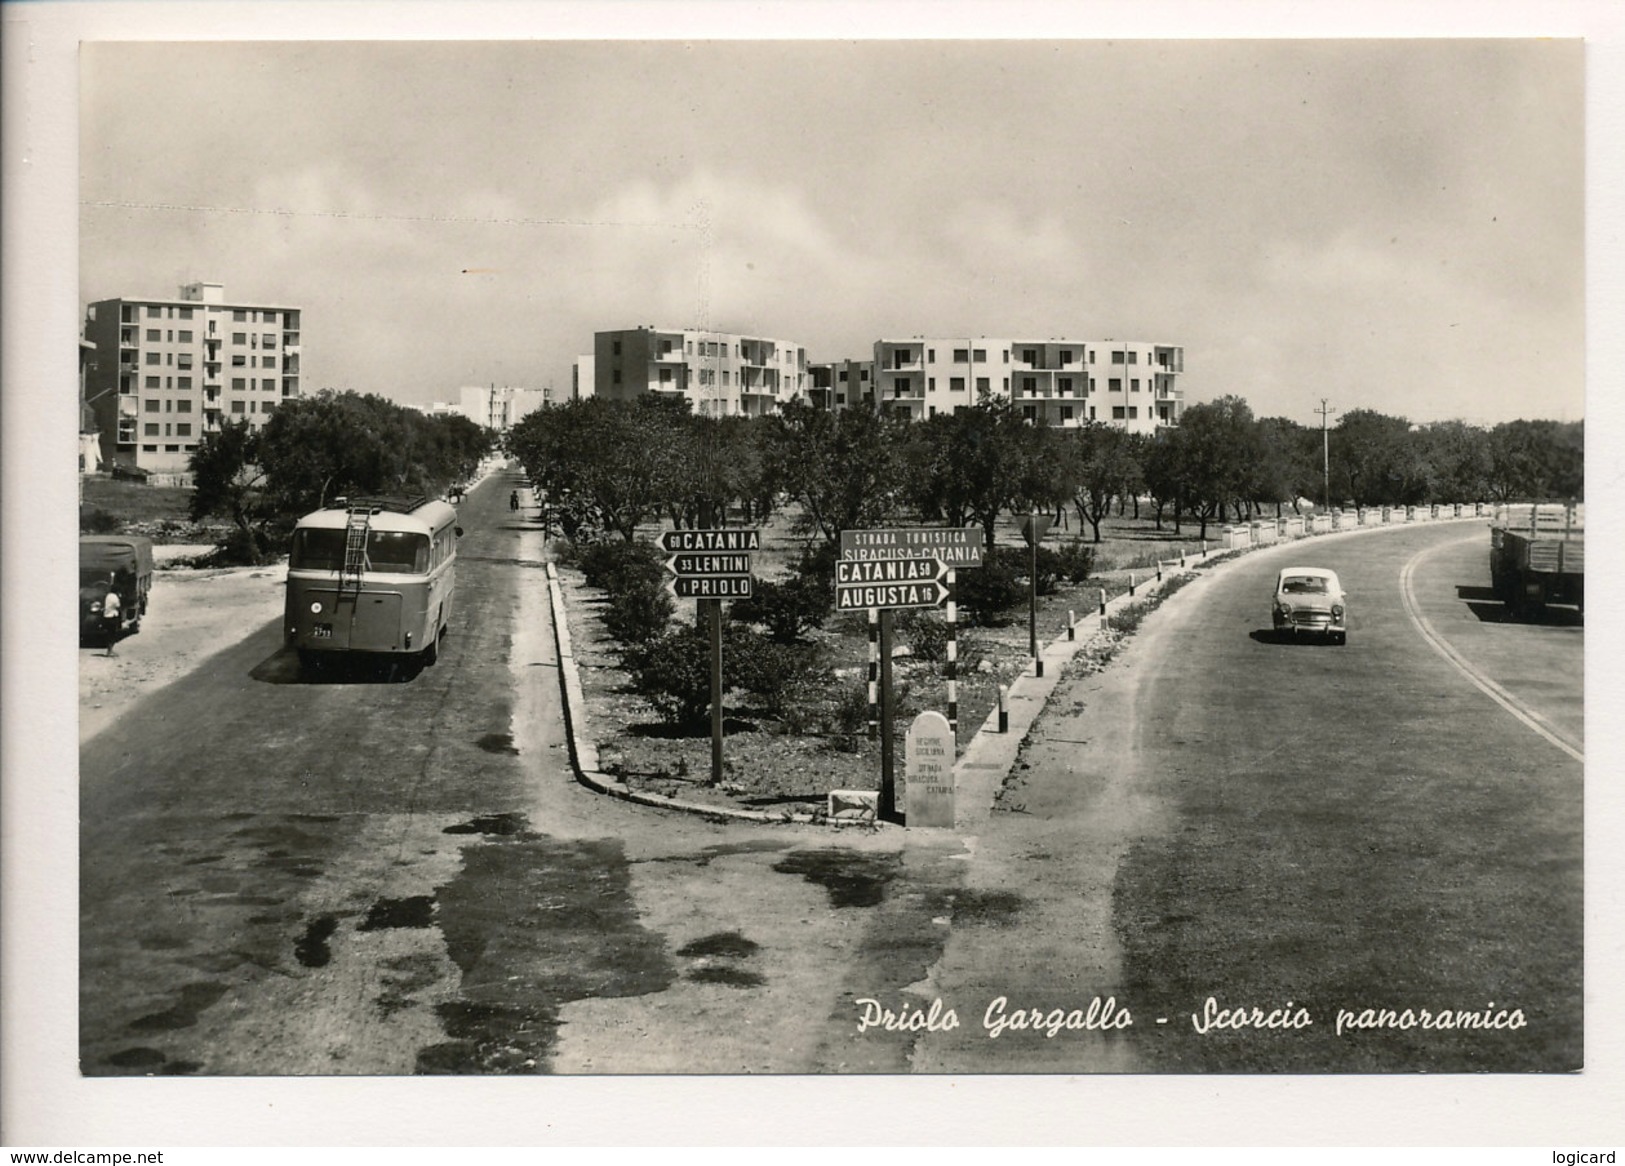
[80,39,1584,424]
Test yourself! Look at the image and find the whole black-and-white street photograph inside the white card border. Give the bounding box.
[7,5,1617,1145]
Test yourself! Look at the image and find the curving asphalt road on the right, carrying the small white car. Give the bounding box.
[913,525,1583,1072]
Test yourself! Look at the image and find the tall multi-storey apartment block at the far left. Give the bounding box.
[85,283,301,474]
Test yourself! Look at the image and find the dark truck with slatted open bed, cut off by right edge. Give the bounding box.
[1490,503,1586,619]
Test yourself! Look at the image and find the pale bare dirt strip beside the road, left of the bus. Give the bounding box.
[78,558,288,744]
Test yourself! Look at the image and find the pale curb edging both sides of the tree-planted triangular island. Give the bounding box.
[548,515,1484,830]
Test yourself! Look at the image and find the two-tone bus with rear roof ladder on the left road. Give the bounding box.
[284,497,463,671]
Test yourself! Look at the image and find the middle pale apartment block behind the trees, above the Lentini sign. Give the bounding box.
[592,326,808,417]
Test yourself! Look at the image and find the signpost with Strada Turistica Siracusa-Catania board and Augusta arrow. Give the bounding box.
[835,526,986,827]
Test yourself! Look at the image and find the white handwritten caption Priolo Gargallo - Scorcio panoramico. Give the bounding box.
[855,995,1529,1039]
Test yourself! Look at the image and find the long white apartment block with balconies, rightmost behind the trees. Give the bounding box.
[873,336,1185,434]
